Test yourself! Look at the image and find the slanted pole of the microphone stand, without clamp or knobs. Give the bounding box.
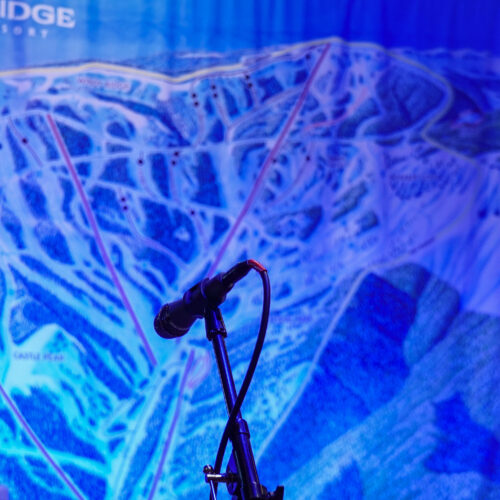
[205,308,266,500]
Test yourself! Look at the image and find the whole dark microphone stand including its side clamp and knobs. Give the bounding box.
[203,307,284,500]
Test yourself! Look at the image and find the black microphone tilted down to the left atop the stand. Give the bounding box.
[154,260,254,339]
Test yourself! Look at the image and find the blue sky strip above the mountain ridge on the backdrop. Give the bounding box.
[0,0,500,69]
